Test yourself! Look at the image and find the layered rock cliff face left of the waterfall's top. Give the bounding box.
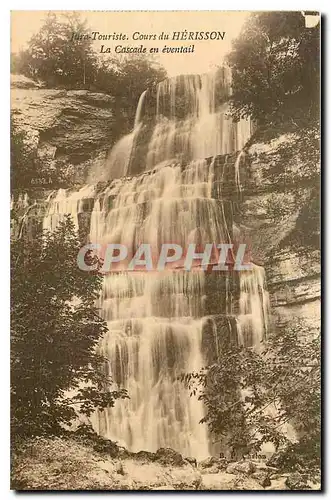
[11,75,115,182]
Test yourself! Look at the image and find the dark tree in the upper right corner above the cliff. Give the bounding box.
[228,12,320,125]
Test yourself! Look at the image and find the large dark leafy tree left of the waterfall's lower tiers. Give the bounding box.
[11,216,127,435]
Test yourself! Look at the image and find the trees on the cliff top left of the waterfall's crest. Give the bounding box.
[11,12,166,129]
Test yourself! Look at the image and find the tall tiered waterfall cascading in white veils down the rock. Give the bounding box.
[44,71,268,459]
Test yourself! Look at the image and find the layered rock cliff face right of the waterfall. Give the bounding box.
[236,131,320,335]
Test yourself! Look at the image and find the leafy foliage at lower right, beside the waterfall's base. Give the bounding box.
[182,325,321,467]
